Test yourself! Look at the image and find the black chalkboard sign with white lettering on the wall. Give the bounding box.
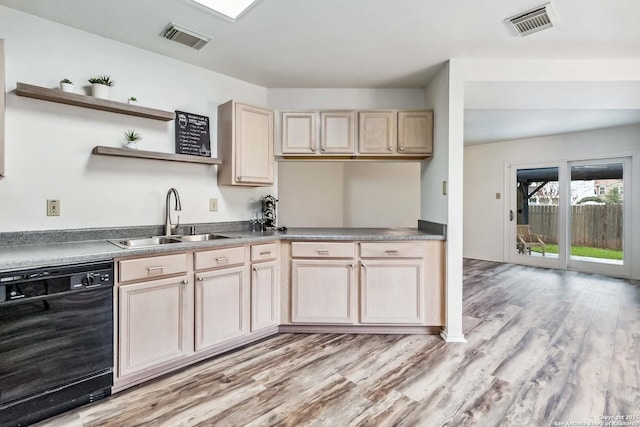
[176,110,211,157]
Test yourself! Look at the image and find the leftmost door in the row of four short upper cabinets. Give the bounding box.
[282,112,318,156]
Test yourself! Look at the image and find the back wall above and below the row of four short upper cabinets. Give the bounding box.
[268,89,425,227]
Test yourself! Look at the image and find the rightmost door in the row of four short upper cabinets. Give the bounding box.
[398,111,433,154]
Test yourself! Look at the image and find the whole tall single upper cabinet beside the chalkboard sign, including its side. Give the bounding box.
[218,100,275,187]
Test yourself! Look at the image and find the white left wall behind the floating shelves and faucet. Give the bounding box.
[0,6,276,231]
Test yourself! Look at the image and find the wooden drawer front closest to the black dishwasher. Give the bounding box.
[118,254,187,282]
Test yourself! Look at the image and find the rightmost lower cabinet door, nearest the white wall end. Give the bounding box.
[360,259,425,325]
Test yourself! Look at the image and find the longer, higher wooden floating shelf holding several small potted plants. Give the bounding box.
[16,82,175,122]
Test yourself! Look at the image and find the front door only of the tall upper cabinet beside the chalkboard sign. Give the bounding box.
[235,104,275,185]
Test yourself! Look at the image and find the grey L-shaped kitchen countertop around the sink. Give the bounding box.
[0,228,444,271]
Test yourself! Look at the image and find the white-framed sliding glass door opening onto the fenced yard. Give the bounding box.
[505,158,632,276]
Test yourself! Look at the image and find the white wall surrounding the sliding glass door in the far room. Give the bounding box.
[464,125,640,274]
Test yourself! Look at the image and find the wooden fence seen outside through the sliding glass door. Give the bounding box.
[529,204,622,250]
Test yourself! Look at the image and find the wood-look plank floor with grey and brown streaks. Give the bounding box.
[37,260,640,427]
